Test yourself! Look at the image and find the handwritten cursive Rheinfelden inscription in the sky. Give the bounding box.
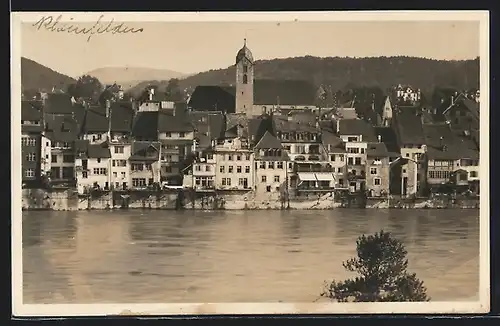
[33,15,144,42]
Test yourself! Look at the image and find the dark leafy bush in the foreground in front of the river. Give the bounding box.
[321,230,430,302]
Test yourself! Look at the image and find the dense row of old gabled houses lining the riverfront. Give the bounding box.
[21,94,479,196]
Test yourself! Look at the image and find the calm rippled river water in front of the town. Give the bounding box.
[23,209,479,303]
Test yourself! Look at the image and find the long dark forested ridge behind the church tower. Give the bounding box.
[171,56,479,94]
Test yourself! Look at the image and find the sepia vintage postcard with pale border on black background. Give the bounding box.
[11,11,490,316]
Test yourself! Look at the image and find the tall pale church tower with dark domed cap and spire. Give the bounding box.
[235,39,254,114]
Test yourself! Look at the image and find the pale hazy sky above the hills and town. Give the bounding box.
[21,21,479,77]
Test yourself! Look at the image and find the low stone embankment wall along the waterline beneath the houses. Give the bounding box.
[22,189,479,211]
